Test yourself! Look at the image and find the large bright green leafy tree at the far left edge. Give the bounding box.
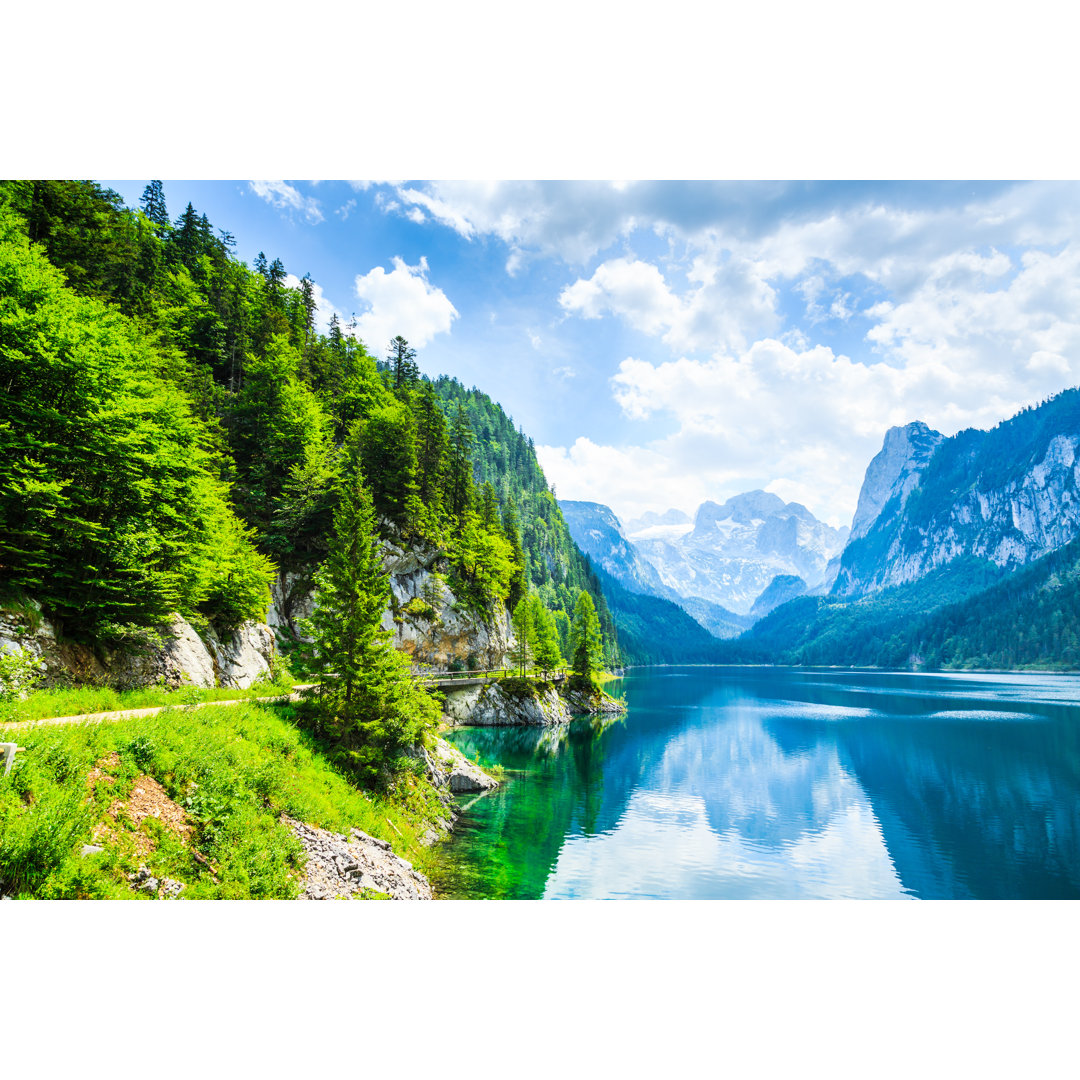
[0,205,271,634]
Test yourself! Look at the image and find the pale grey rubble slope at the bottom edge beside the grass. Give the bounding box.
[281,814,431,900]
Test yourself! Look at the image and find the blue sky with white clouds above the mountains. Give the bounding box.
[105,180,1080,525]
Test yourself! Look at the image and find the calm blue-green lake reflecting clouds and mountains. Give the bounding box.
[432,667,1080,900]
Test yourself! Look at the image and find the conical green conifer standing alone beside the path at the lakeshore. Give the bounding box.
[307,459,438,783]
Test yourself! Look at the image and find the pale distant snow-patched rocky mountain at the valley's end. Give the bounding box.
[629,490,849,615]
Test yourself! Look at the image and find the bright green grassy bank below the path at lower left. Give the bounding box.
[0,704,442,900]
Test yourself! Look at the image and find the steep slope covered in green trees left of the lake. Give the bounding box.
[0,181,619,661]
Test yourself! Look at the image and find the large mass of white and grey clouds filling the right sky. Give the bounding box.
[352,183,1080,531]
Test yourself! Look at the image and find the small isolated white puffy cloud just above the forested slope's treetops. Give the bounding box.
[356,256,458,354]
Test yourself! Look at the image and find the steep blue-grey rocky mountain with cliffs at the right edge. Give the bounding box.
[832,389,1080,596]
